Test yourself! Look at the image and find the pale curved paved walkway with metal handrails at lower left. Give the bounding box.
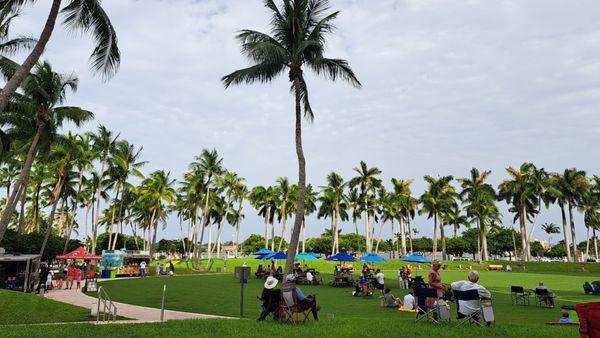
[45,289,232,322]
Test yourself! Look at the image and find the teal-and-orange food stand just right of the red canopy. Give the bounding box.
[100,249,150,278]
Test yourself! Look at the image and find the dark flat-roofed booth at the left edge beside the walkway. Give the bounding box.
[0,254,41,292]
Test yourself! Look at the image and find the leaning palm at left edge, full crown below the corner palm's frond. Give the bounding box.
[0,59,93,241]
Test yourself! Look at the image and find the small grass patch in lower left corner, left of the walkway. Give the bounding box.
[0,290,92,324]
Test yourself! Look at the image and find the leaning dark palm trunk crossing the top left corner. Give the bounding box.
[0,0,61,111]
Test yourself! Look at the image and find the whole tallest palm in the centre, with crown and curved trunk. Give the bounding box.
[222,0,361,272]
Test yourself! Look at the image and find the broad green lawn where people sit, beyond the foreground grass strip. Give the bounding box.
[89,270,598,334]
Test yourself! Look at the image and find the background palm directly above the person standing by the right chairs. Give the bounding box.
[419,175,457,259]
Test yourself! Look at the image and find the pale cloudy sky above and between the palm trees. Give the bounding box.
[8,0,600,247]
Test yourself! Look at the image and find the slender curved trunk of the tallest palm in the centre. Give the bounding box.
[285,72,306,274]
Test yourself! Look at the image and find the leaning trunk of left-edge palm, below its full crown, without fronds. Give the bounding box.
[0,123,43,242]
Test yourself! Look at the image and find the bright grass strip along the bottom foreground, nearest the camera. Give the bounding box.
[0,318,577,338]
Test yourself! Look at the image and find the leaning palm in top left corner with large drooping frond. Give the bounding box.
[0,0,121,111]
